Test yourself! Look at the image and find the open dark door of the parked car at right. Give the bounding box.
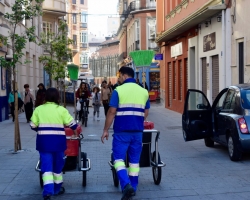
[182,89,213,141]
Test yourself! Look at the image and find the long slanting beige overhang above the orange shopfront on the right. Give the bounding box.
[155,4,226,43]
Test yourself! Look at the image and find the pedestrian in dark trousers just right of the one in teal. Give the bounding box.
[23,84,34,123]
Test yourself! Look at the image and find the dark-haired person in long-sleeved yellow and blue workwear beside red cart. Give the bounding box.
[30,88,77,200]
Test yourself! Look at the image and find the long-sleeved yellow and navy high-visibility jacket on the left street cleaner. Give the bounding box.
[30,102,77,152]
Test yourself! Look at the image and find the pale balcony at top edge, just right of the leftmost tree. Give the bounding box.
[43,0,66,17]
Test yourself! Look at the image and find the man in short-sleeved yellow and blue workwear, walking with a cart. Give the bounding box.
[101,67,150,200]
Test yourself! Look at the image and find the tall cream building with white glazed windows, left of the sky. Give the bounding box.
[66,0,89,72]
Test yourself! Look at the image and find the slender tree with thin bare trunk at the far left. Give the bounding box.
[0,0,43,152]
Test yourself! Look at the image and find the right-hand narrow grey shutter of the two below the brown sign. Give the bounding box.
[212,55,219,101]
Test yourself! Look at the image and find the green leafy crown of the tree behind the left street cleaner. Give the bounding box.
[39,20,73,87]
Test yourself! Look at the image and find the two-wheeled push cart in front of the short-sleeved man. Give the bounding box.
[108,122,166,187]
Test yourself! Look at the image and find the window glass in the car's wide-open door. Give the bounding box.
[187,91,210,110]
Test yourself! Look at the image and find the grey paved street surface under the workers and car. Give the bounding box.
[0,104,250,200]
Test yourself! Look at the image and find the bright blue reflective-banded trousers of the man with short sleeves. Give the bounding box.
[112,132,142,191]
